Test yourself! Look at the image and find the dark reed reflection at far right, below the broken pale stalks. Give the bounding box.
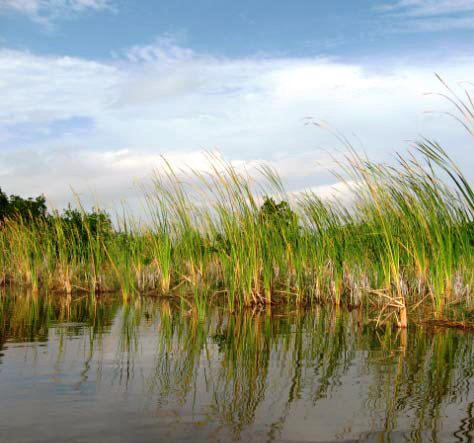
[358,328,474,441]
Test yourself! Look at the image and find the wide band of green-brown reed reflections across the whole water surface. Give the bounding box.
[0,294,474,441]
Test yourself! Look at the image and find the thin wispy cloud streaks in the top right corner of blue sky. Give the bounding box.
[376,0,474,32]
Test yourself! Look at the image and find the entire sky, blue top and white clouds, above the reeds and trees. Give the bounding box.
[0,0,474,212]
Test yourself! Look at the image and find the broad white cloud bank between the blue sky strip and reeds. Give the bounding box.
[0,41,474,213]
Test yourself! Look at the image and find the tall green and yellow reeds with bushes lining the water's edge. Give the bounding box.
[0,82,474,327]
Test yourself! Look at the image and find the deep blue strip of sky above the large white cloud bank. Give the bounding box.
[0,0,474,59]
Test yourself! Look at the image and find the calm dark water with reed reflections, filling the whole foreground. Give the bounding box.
[0,294,474,442]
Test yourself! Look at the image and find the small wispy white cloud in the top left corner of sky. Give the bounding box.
[0,0,115,26]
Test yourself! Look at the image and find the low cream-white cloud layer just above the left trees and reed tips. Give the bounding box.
[0,149,340,210]
